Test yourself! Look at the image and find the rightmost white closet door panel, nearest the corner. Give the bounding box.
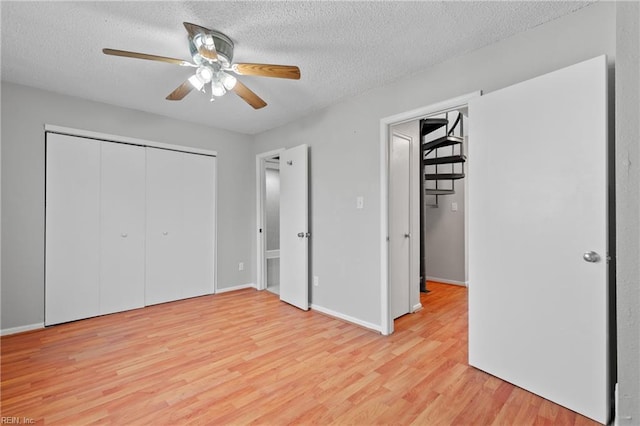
[182,154,216,298]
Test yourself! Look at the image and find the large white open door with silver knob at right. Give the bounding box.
[469,57,610,423]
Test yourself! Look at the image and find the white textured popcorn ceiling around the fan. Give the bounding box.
[1,1,592,134]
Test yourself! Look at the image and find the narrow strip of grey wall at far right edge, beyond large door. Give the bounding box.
[615,2,640,425]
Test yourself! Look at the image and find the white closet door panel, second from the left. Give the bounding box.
[100,142,145,314]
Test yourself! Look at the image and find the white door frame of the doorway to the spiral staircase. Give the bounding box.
[380,90,482,335]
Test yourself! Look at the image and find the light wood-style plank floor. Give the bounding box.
[1,283,594,425]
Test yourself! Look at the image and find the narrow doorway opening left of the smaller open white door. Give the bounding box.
[256,149,283,294]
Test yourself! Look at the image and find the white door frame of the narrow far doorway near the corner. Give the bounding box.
[256,148,284,290]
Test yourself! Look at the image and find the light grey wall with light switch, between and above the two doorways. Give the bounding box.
[254,2,615,324]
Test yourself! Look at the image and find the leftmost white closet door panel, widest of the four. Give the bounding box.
[45,133,100,325]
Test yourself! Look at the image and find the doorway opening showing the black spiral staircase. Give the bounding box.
[389,107,468,320]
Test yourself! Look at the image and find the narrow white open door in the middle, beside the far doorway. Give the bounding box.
[280,145,310,311]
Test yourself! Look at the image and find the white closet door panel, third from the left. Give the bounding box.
[145,148,184,305]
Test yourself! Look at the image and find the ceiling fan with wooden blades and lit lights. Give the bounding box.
[102,22,300,109]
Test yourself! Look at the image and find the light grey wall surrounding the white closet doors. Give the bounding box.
[0,82,255,330]
